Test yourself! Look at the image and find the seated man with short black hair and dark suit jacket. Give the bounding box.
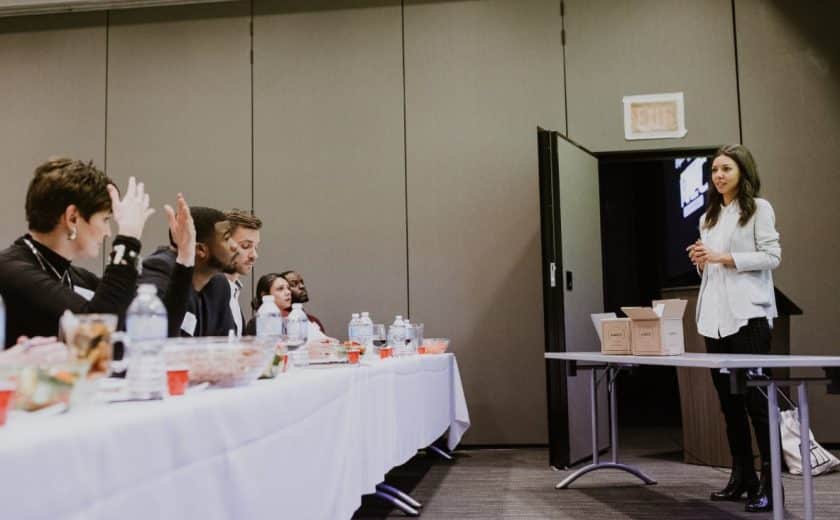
[140,207,239,336]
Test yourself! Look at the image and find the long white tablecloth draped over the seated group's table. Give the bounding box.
[0,354,469,520]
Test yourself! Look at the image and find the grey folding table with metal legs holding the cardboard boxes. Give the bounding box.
[545,352,840,520]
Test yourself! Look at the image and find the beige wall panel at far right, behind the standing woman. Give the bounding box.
[735,1,840,443]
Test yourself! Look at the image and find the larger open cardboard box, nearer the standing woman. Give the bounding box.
[621,300,688,356]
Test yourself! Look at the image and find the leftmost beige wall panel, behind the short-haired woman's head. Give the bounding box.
[0,13,105,273]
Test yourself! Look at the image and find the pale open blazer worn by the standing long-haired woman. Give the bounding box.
[697,198,782,319]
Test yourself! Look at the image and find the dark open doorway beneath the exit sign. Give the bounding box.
[597,148,715,427]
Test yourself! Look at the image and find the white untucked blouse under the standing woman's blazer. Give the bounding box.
[697,200,757,338]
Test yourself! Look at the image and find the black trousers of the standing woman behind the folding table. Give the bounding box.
[706,318,770,464]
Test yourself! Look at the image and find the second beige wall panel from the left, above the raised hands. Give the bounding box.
[108,3,251,300]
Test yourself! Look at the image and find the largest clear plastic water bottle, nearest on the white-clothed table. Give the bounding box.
[125,284,167,399]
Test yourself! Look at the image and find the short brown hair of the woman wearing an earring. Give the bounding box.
[26,157,114,233]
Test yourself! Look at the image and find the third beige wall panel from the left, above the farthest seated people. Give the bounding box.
[254,2,407,338]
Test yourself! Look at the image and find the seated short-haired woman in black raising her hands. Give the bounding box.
[0,158,154,347]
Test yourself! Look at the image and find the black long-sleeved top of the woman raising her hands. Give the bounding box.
[0,234,140,347]
